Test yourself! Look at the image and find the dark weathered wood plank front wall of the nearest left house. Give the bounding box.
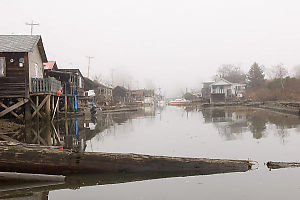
[0,53,28,97]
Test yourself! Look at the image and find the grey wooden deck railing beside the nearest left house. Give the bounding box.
[31,77,61,94]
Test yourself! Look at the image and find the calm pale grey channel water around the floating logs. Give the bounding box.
[0,107,300,200]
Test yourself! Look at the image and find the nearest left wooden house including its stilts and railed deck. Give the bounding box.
[0,35,61,120]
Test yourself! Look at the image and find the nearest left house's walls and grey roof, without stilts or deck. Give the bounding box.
[0,35,59,97]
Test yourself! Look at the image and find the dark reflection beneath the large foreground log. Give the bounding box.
[0,170,211,200]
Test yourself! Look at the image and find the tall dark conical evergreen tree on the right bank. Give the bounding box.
[247,62,265,87]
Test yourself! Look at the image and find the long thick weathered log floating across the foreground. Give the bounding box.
[0,142,251,175]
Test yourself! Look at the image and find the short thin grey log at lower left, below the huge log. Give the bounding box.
[0,172,65,182]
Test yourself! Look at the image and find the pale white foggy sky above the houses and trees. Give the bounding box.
[0,0,300,95]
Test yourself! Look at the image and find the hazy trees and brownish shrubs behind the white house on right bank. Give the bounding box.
[217,62,300,101]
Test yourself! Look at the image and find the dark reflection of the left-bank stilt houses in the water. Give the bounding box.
[0,107,162,152]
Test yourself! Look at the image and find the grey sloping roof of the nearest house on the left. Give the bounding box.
[0,35,41,52]
